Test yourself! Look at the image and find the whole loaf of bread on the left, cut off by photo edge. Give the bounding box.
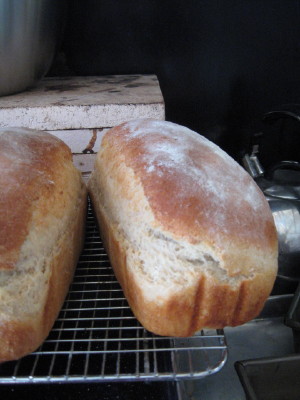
[0,128,87,362]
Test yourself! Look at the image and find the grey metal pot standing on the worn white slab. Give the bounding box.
[0,0,66,96]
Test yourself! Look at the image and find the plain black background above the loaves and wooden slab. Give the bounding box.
[50,0,300,163]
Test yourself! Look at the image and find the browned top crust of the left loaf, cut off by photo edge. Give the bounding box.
[0,129,71,269]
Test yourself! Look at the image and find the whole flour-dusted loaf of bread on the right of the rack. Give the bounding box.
[88,119,277,337]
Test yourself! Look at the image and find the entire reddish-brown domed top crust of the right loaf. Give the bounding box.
[102,120,277,276]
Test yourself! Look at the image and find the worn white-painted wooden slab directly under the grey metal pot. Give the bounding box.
[0,75,165,131]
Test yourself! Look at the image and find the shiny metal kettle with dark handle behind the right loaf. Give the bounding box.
[242,111,300,294]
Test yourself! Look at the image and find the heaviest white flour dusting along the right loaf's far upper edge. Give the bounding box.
[126,120,261,207]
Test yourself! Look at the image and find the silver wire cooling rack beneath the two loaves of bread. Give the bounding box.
[0,202,227,383]
